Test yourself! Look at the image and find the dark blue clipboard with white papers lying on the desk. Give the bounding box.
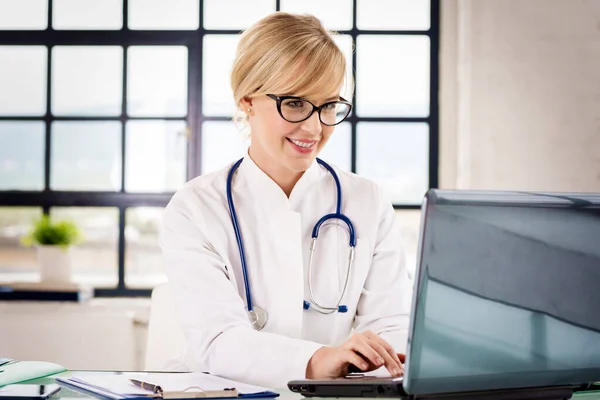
[55,372,279,400]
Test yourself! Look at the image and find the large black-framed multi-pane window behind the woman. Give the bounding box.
[0,0,439,296]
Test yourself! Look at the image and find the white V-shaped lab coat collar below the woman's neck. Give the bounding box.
[239,154,322,210]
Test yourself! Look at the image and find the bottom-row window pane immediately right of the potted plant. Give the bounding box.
[50,207,119,287]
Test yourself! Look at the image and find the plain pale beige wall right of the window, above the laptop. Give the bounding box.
[397,0,600,274]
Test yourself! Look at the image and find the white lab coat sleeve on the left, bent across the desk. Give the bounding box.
[161,189,322,388]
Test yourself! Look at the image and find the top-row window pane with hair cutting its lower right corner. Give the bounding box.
[204,0,275,30]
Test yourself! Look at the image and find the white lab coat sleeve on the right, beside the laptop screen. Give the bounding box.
[354,185,412,353]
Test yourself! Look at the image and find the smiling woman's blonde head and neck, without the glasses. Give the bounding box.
[231,12,346,192]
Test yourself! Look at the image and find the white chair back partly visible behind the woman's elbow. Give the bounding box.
[145,283,189,371]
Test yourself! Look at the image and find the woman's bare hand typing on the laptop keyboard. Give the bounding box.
[306,331,404,379]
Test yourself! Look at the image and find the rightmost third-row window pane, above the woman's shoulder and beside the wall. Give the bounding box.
[356,122,429,204]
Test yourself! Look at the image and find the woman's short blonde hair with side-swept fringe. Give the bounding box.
[231,12,351,126]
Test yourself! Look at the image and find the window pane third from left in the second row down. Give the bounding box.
[127,46,188,117]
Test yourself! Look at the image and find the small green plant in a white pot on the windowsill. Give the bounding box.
[21,215,82,283]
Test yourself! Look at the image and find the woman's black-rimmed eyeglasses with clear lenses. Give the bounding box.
[267,94,352,126]
